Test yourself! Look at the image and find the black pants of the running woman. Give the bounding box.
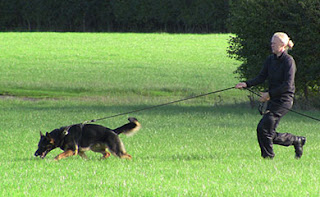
[257,98,297,158]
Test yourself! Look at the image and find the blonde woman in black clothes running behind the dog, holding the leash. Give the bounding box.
[235,32,306,159]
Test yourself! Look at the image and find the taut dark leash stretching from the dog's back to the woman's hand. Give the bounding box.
[82,87,234,124]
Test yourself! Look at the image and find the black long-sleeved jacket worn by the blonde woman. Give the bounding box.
[246,52,296,100]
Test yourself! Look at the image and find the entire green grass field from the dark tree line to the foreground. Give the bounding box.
[0,33,320,196]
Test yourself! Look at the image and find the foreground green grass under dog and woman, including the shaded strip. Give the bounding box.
[0,100,320,196]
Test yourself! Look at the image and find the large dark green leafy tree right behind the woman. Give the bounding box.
[228,0,320,98]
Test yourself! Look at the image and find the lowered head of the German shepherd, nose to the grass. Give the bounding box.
[34,131,56,159]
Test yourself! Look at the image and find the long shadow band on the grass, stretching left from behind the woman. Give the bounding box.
[11,101,318,124]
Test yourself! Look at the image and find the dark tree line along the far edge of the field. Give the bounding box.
[0,0,229,33]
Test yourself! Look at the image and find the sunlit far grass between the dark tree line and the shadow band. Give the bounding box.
[0,33,239,101]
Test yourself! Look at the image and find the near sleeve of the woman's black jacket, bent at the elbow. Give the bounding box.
[269,58,296,98]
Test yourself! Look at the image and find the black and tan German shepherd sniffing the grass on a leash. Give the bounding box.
[34,117,141,160]
